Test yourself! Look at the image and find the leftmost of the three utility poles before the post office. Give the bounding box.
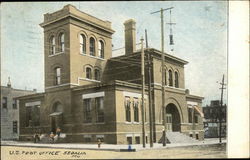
[141,37,146,148]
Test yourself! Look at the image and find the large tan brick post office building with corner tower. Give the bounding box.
[18,5,204,144]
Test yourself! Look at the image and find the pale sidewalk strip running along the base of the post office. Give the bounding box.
[1,138,227,151]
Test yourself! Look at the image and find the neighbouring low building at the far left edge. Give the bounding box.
[1,79,35,140]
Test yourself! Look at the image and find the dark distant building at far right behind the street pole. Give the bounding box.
[203,100,227,138]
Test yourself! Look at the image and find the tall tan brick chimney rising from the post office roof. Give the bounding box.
[124,19,136,55]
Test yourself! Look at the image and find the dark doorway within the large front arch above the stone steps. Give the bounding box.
[166,103,181,132]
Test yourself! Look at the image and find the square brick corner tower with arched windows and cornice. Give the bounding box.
[40,5,114,90]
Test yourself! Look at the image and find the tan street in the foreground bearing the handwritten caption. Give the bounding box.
[1,143,227,160]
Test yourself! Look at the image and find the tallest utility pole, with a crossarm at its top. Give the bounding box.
[151,7,174,146]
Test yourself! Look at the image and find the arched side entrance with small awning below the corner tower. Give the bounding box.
[50,102,63,133]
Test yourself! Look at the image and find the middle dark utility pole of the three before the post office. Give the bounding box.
[145,30,153,147]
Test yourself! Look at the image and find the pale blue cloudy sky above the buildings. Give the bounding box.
[1,1,227,106]
